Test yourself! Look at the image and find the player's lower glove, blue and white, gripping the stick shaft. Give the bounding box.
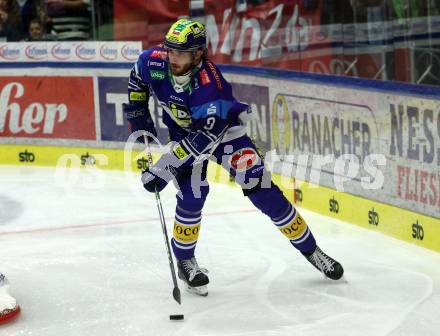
[141,153,183,192]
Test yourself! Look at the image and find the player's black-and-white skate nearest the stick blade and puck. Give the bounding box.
[177,257,209,296]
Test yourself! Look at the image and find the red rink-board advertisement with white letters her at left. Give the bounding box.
[0,77,96,140]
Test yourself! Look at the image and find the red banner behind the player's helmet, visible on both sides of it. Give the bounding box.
[114,0,332,71]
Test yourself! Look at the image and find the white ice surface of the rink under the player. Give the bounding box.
[0,166,440,336]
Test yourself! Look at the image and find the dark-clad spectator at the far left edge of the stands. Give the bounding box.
[0,0,23,42]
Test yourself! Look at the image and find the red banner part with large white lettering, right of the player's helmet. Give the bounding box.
[205,0,324,70]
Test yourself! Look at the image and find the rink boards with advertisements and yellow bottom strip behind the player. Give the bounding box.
[0,50,440,251]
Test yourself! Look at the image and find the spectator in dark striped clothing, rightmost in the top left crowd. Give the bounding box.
[46,0,91,41]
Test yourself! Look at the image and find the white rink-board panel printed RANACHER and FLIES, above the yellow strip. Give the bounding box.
[223,74,440,223]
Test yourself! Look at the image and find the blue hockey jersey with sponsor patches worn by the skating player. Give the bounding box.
[128,47,249,164]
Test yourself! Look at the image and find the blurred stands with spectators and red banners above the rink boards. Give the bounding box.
[0,0,440,85]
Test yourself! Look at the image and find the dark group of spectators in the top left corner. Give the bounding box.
[0,0,92,42]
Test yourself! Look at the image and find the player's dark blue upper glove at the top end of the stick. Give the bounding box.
[122,103,157,143]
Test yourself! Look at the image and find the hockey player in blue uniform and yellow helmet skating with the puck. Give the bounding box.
[123,19,344,295]
